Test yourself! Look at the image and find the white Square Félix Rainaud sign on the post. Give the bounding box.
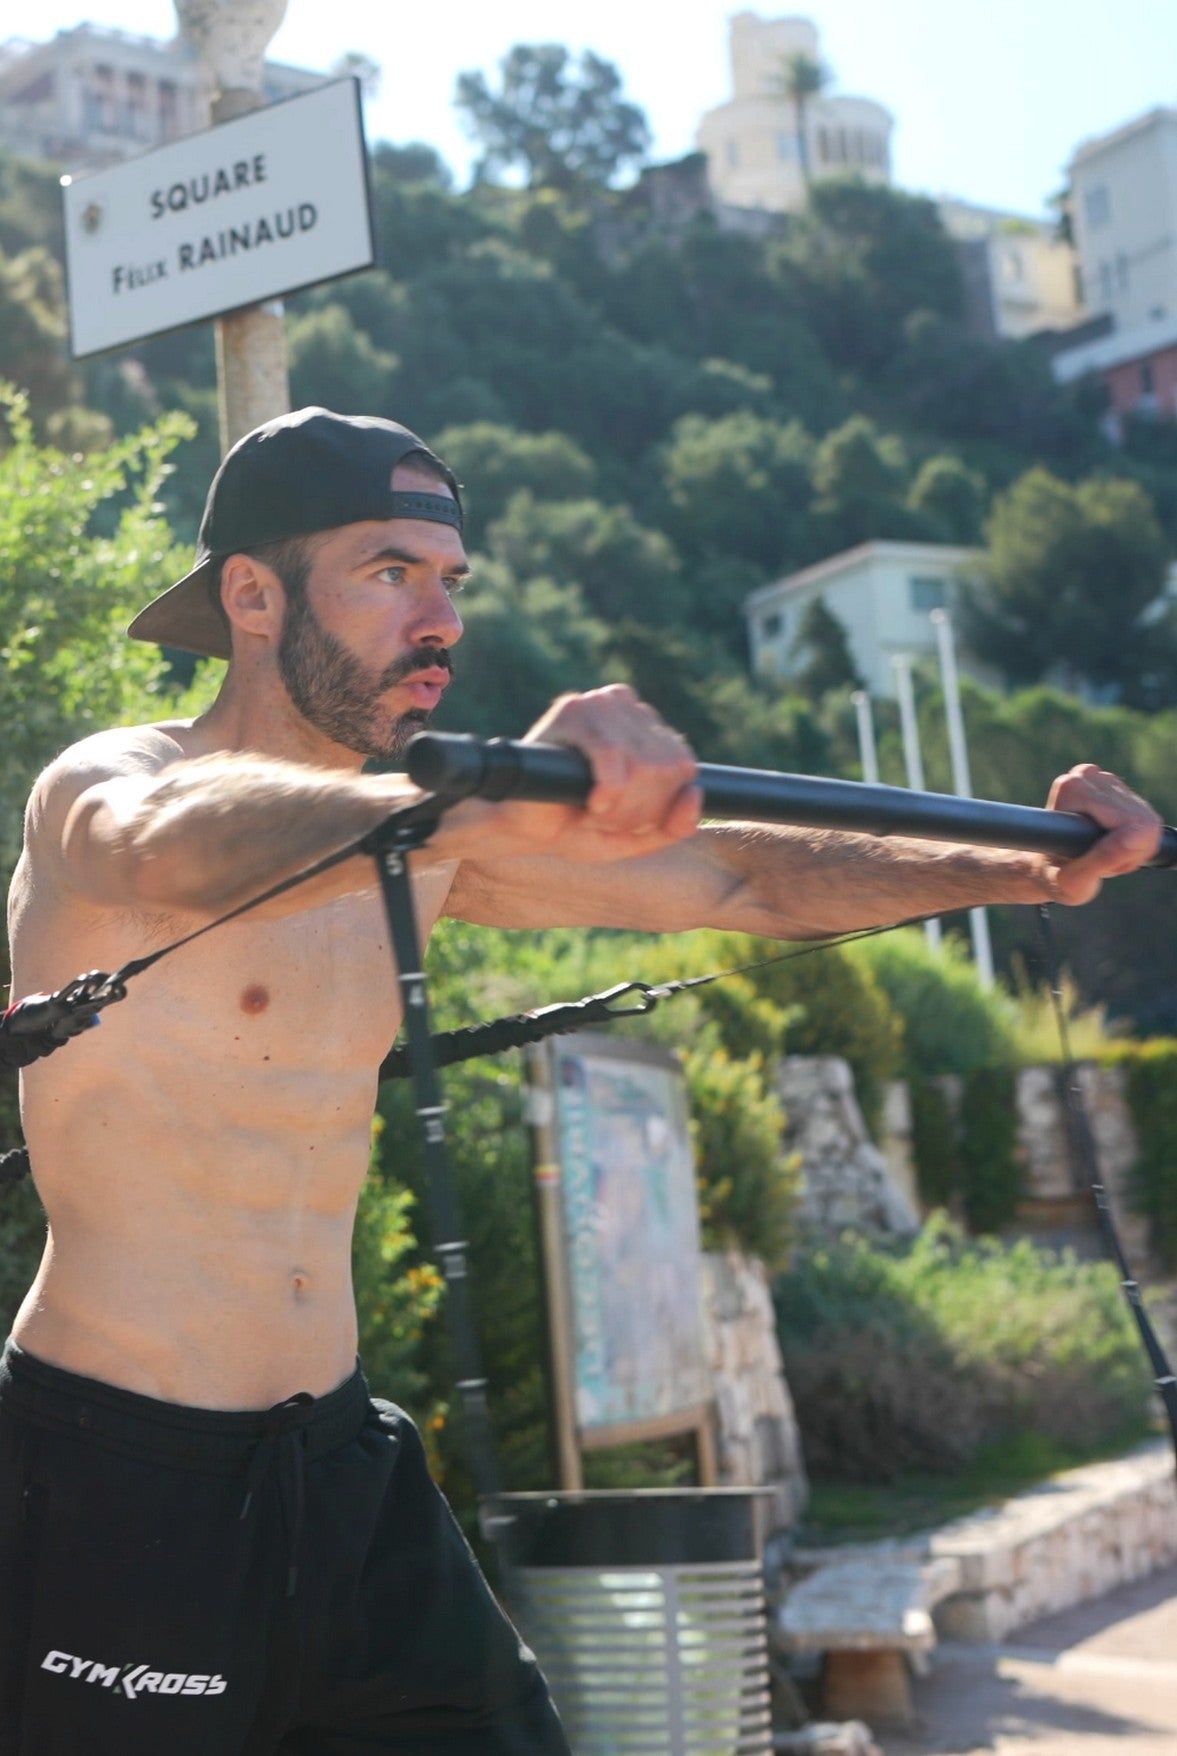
[63,79,376,358]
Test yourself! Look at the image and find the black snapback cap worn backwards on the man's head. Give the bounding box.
[126,407,462,659]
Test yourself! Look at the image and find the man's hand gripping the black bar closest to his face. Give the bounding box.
[467,683,703,864]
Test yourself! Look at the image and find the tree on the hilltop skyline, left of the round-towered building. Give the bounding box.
[455,42,650,190]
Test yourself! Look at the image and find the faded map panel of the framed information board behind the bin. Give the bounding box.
[550,1033,711,1447]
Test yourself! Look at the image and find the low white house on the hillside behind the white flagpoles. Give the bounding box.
[743,543,994,699]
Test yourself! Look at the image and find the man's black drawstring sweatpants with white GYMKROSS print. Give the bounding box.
[0,1342,567,1756]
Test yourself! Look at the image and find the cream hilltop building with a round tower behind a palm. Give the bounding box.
[696,12,892,212]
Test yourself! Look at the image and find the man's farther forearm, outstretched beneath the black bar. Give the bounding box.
[706,824,1052,939]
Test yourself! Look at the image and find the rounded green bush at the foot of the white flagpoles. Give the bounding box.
[850,927,1015,1075]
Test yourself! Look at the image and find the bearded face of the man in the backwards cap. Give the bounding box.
[278,469,469,760]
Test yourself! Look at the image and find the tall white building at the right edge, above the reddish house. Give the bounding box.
[1068,109,1177,330]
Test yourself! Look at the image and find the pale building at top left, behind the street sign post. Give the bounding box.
[0,25,323,170]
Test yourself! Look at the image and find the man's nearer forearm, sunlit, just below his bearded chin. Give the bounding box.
[61,755,419,913]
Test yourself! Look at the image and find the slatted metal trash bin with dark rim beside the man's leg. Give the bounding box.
[488,1487,773,1756]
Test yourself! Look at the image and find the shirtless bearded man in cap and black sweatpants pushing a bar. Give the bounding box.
[0,409,1159,1756]
